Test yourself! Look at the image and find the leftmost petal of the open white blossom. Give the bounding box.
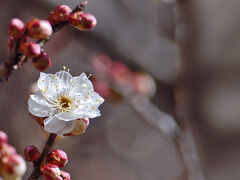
[28,91,51,117]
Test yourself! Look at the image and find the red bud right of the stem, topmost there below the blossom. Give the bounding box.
[46,149,68,168]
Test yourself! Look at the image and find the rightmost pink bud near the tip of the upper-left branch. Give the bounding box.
[69,11,97,30]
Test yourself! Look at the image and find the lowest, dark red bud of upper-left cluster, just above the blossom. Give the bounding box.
[32,52,51,71]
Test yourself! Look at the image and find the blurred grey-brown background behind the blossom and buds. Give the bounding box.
[0,0,240,180]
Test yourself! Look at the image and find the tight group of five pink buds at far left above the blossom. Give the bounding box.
[8,18,53,71]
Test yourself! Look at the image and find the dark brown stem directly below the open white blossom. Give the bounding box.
[28,133,57,180]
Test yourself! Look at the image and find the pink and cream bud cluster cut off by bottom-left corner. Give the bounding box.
[0,131,26,180]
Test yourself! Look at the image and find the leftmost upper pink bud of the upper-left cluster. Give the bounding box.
[8,18,24,38]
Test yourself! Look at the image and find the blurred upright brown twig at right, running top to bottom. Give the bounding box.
[175,0,206,180]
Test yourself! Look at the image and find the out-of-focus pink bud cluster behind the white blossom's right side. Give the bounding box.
[93,54,156,98]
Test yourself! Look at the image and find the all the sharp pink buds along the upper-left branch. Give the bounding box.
[8,3,97,71]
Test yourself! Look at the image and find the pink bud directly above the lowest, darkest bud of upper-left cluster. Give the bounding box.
[23,42,42,58]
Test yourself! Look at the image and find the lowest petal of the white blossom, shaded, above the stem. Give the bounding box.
[44,116,76,134]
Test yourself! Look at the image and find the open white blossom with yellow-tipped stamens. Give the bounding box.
[28,67,104,134]
